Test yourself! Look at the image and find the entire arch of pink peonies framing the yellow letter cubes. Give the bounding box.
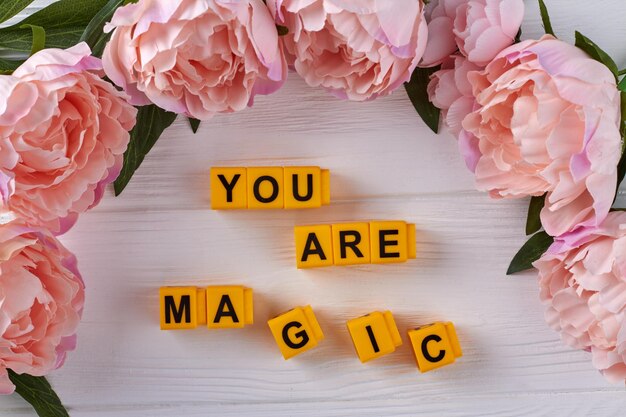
[0,0,626,386]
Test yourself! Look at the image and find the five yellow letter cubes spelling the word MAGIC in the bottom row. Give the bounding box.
[159,285,463,372]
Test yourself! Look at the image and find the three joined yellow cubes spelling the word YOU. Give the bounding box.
[211,167,330,210]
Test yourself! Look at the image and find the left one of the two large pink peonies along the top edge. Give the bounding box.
[103,0,287,120]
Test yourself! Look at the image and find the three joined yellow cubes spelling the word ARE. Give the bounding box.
[294,221,416,268]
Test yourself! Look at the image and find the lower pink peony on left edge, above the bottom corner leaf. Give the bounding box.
[0,214,85,394]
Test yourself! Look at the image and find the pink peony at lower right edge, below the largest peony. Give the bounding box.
[534,212,626,383]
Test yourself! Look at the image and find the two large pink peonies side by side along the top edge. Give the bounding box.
[103,0,428,120]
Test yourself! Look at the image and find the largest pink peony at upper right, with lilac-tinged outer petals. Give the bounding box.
[462,36,621,236]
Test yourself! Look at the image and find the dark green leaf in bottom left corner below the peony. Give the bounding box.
[9,369,69,417]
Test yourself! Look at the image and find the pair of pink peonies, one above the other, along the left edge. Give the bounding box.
[0,43,136,393]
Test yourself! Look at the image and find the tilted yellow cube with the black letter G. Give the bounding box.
[267,306,324,360]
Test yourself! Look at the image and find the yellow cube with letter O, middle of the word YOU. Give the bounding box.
[248,167,285,209]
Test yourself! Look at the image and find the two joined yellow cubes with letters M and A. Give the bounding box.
[159,285,254,330]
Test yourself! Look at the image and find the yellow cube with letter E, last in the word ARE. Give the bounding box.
[370,221,416,264]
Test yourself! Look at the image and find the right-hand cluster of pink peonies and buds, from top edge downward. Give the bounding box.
[421,0,626,381]
